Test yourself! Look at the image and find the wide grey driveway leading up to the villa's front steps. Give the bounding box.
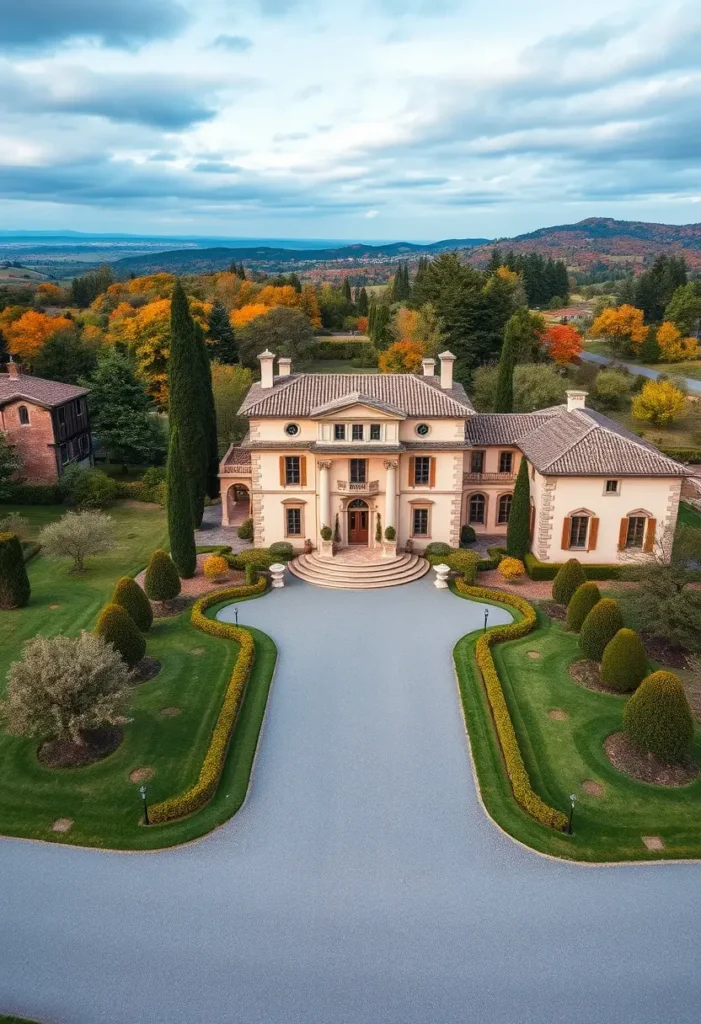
[0,580,701,1024]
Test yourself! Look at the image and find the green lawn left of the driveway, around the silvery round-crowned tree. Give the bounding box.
[0,507,276,850]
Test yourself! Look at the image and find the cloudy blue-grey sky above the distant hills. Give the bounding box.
[0,0,701,240]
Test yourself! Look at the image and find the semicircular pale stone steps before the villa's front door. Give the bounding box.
[288,554,431,590]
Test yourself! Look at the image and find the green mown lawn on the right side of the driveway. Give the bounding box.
[454,593,701,862]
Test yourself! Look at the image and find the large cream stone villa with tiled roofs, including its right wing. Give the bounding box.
[220,351,687,563]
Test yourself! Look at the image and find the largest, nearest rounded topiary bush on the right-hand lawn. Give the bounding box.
[623,672,694,761]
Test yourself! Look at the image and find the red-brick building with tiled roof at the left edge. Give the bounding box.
[0,362,93,483]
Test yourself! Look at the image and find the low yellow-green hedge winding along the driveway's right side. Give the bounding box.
[455,580,567,831]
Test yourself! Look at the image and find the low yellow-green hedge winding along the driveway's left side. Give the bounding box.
[148,578,267,824]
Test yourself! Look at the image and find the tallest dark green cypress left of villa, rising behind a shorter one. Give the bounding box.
[168,281,206,526]
